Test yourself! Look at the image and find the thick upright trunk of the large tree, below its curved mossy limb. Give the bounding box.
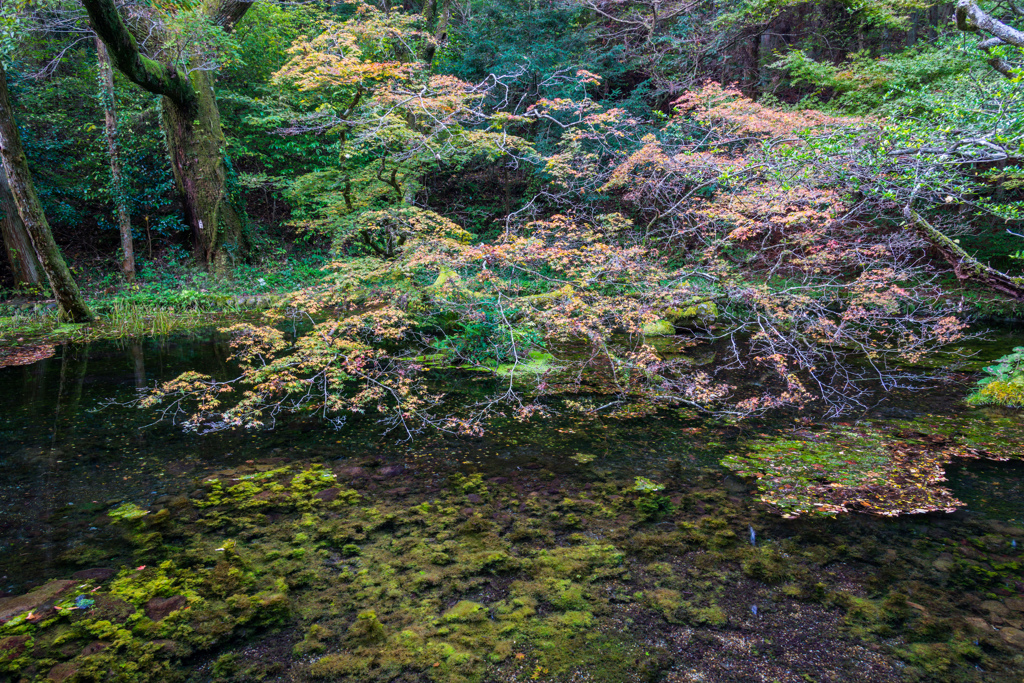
[162,72,248,270]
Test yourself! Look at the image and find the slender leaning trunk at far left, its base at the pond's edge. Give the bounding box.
[0,63,93,323]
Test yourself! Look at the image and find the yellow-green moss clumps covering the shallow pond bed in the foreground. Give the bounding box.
[9,458,1024,683]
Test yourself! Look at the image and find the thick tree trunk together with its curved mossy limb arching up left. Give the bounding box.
[82,0,253,270]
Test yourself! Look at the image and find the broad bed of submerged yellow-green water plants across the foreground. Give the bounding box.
[0,462,1024,683]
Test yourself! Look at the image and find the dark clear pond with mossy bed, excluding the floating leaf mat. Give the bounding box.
[0,332,1024,682]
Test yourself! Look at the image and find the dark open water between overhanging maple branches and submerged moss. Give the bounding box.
[0,332,1024,591]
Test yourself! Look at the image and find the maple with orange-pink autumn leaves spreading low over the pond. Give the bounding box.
[144,68,964,434]
